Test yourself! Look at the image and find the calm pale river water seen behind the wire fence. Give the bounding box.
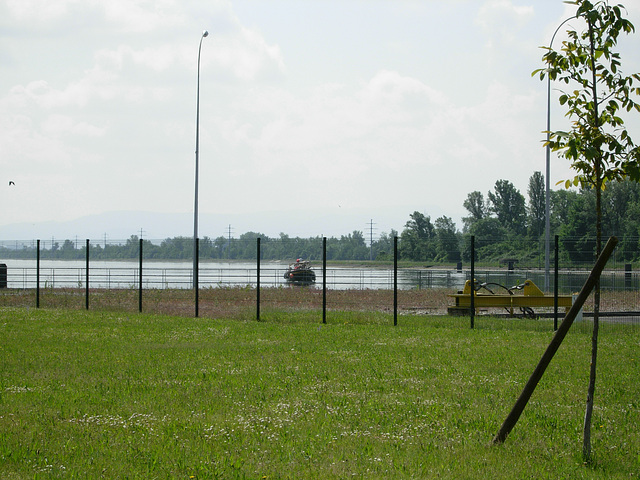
[0,260,640,294]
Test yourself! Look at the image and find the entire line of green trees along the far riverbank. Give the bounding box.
[0,172,640,265]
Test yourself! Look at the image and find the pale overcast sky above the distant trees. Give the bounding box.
[0,0,640,239]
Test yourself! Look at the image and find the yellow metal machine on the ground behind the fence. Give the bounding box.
[447,280,573,316]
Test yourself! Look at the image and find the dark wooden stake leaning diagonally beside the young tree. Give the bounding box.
[493,237,618,444]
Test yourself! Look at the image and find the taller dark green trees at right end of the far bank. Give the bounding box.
[399,172,640,265]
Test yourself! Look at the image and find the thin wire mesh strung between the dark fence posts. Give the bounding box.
[0,237,640,334]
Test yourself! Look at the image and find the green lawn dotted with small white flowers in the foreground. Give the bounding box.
[0,308,640,479]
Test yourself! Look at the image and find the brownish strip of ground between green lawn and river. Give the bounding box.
[0,285,640,323]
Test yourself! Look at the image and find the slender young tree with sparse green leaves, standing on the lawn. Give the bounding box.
[534,0,640,461]
